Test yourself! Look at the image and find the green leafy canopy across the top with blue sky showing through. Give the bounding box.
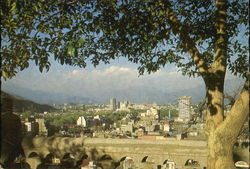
[1,0,248,78]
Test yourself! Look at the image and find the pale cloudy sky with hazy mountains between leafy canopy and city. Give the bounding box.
[2,59,243,104]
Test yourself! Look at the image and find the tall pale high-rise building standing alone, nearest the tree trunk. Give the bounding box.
[178,96,191,121]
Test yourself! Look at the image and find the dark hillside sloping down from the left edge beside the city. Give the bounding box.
[1,91,56,113]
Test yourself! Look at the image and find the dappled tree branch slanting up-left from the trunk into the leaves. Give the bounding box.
[160,0,209,77]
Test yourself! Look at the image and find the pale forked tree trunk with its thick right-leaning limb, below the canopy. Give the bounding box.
[206,79,249,169]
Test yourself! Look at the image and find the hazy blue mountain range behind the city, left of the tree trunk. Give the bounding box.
[1,83,205,105]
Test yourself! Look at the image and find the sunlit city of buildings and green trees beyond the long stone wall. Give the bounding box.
[20,96,206,139]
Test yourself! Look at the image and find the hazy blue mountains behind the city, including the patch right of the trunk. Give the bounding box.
[3,79,244,105]
